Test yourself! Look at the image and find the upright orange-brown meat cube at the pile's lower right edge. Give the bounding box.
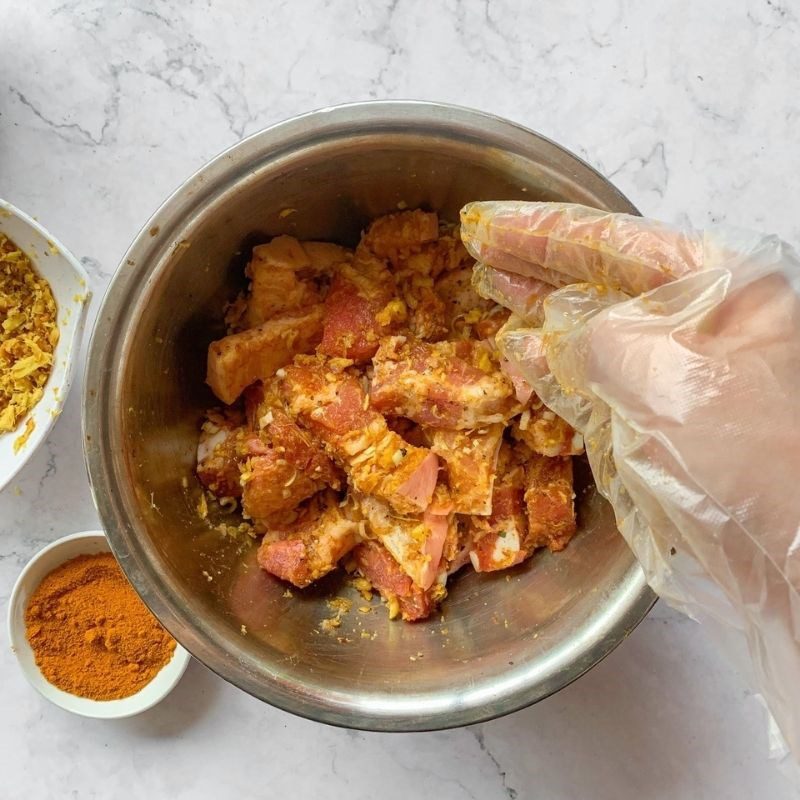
[525,453,577,552]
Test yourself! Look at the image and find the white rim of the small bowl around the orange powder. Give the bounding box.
[6,530,191,719]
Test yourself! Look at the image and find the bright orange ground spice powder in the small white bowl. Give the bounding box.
[25,553,175,700]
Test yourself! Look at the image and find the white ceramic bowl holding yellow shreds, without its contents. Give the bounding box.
[0,199,91,490]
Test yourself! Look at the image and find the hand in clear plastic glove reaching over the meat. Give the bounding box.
[461,202,800,757]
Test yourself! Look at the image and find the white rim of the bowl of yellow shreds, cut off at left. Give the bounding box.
[0,198,92,492]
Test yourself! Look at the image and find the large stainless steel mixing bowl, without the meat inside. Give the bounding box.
[84,102,654,730]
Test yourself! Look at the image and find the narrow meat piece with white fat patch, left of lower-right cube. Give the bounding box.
[469,443,533,572]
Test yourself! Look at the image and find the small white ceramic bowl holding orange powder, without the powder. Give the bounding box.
[8,531,191,719]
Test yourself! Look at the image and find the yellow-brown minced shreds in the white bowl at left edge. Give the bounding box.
[0,234,59,440]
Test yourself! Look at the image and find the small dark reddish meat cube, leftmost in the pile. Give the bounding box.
[196,411,251,498]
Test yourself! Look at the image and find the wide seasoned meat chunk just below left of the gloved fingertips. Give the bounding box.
[370,336,520,430]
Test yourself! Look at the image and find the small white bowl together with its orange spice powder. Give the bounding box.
[8,531,189,719]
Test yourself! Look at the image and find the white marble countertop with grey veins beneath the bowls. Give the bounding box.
[0,0,800,800]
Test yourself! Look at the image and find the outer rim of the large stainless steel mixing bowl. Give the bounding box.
[82,100,656,732]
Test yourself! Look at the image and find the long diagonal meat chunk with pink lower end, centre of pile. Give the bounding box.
[281,358,439,514]
